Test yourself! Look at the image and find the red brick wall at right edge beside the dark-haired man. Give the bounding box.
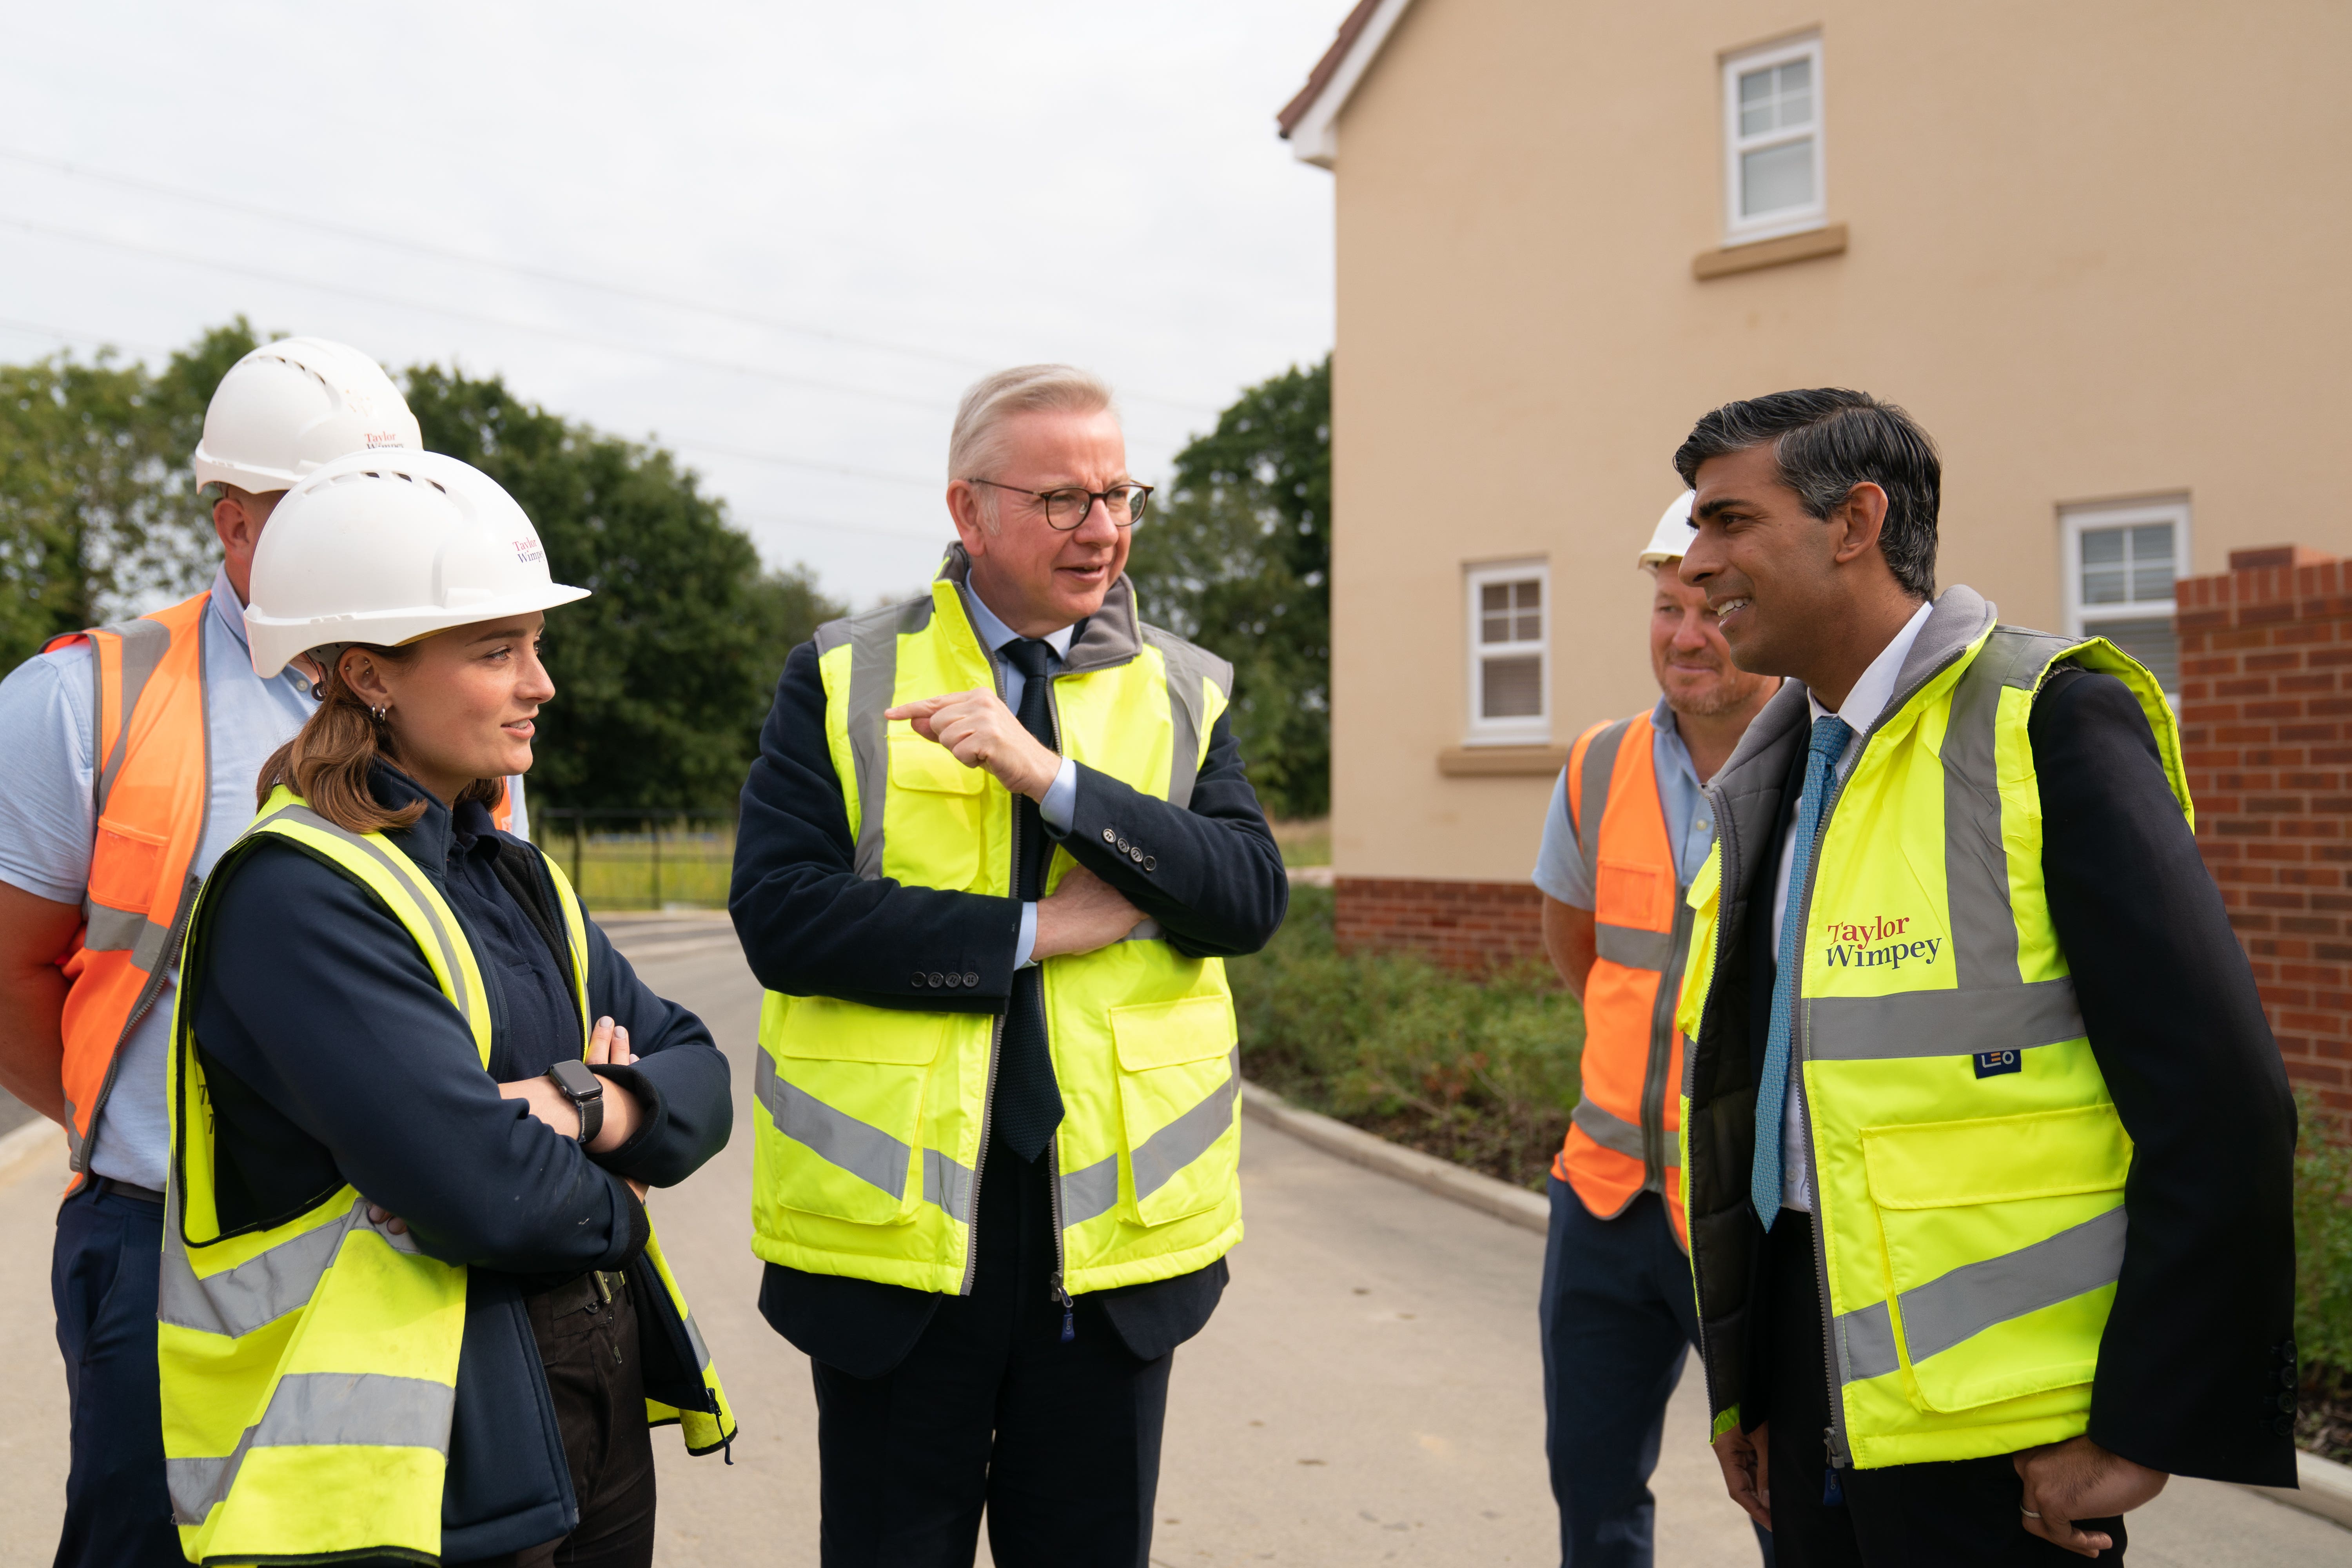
[2176,545,2352,1112]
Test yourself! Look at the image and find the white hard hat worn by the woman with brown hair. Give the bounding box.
[245,451,588,679]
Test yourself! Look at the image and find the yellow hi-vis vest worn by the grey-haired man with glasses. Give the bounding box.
[753,548,1242,1295]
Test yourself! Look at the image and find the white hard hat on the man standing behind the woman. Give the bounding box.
[195,339,426,491]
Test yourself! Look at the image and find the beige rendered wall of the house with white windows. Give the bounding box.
[1331,0,2352,903]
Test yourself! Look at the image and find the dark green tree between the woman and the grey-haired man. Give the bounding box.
[407,365,842,811]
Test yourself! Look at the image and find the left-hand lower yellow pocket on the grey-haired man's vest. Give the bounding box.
[753,992,953,1225]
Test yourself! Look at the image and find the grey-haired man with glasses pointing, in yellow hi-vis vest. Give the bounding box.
[729,365,1289,1568]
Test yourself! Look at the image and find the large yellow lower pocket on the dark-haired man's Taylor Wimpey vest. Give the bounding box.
[1860,1103,2131,1413]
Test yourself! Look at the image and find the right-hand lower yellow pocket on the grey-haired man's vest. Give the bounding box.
[1110,992,1242,1225]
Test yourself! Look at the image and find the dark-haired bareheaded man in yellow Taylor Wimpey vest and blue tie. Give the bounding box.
[1675,388,2296,1568]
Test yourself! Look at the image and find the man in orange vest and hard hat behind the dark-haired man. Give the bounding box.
[1536,494,1780,1568]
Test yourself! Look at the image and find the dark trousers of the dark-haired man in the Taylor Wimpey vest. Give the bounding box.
[1764,1208,2124,1568]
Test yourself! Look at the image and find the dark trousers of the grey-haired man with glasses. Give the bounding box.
[811,1143,1174,1568]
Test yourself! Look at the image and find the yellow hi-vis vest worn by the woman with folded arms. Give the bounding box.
[155,788,736,1563]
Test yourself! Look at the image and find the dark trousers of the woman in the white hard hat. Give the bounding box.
[452,1274,654,1568]
